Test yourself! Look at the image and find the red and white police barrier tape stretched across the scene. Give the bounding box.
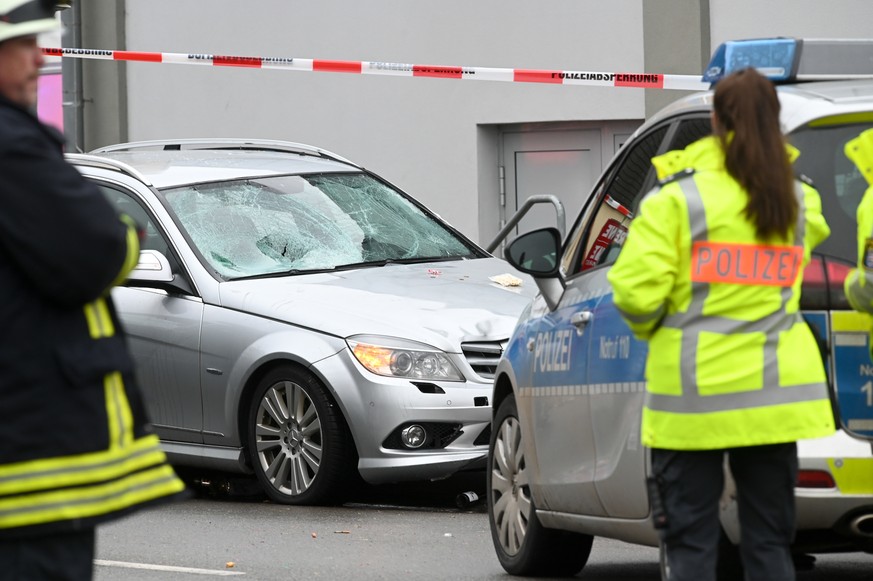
[42,48,709,91]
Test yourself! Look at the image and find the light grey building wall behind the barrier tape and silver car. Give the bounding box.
[77,0,873,243]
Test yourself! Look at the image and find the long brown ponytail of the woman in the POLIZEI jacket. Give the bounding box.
[713,69,798,241]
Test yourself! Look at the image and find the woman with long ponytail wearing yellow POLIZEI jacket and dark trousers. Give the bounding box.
[609,69,835,581]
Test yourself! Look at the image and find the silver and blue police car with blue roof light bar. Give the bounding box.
[487,38,873,576]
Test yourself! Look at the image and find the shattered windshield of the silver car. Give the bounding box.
[164,173,480,278]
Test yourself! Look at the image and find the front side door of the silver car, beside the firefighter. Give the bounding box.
[98,182,203,443]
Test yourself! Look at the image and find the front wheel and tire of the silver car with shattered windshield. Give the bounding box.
[247,366,358,505]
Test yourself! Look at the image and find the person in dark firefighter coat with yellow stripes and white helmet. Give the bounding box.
[0,0,184,581]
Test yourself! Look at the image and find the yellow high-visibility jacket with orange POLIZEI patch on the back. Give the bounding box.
[609,137,835,450]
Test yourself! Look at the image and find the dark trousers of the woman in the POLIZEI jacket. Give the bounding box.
[652,442,797,581]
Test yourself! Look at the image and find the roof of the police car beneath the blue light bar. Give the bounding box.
[637,79,873,133]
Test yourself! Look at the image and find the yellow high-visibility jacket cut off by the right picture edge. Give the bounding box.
[844,129,873,313]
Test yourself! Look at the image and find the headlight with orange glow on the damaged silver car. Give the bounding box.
[346,335,464,381]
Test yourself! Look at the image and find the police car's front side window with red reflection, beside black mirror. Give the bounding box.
[567,125,669,274]
